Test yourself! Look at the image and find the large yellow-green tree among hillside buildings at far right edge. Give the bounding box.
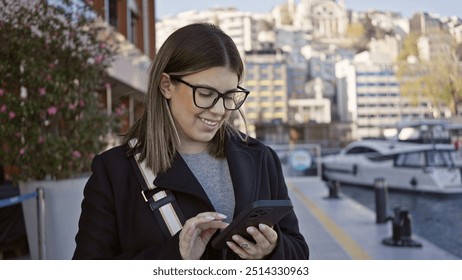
[397,31,462,116]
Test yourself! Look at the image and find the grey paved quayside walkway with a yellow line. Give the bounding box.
[286,178,459,260]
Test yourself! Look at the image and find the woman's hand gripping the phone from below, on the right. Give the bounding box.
[226,224,278,260]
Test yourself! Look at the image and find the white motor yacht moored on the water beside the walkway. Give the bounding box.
[321,140,462,193]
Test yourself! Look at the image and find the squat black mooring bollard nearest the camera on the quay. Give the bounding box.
[382,206,422,247]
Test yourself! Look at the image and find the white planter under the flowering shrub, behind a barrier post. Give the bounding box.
[19,177,89,260]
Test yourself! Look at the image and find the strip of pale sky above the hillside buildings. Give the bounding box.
[156,0,462,18]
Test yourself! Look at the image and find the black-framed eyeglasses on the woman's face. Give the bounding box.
[170,76,250,111]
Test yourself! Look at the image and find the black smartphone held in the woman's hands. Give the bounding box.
[212,200,293,249]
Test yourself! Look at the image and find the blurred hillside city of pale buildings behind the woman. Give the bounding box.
[156,0,462,147]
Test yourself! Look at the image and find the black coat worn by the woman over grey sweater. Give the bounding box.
[73,137,309,259]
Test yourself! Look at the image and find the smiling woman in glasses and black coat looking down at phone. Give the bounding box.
[74,24,308,259]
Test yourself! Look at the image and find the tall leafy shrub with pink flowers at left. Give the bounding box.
[0,0,115,181]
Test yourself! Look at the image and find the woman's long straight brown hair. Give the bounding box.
[125,23,247,174]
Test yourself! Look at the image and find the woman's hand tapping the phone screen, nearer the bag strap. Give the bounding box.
[180,212,228,260]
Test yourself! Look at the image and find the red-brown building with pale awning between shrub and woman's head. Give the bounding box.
[92,0,156,136]
